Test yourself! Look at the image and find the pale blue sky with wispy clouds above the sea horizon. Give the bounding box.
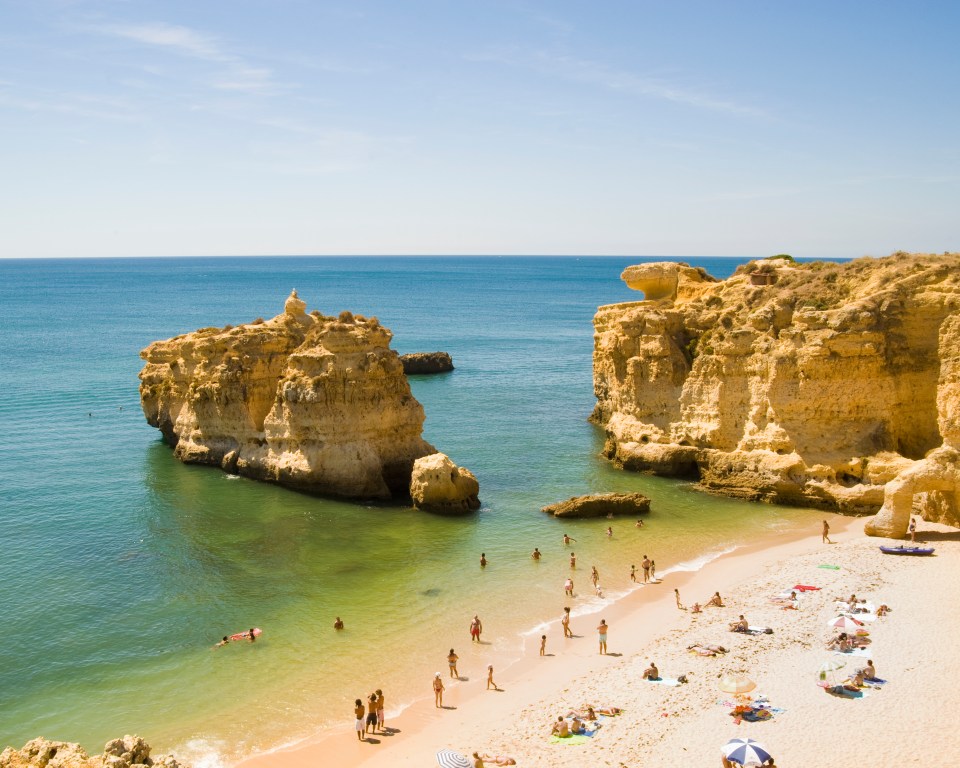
[0,0,960,258]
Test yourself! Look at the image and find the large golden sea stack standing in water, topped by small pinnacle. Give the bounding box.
[140,291,435,499]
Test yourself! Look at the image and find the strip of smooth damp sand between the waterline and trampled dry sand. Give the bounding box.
[237,513,864,768]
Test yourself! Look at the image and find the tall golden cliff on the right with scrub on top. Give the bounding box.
[591,253,960,530]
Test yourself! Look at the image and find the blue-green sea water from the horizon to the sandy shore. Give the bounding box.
[0,258,824,763]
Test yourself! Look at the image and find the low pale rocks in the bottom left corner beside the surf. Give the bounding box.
[0,736,182,768]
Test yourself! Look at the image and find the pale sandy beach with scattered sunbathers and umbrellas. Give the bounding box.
[241,516,960,768]
